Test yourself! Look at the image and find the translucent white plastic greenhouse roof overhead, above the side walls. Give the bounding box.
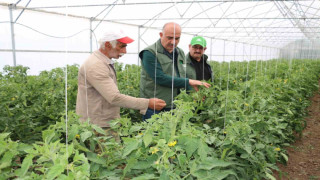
[0,0,320,48]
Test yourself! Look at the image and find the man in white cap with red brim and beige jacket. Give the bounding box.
[76,30,166,132]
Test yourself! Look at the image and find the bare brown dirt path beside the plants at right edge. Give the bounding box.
[274,80,320,180]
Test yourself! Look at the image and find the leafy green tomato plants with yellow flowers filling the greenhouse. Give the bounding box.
[0,60,320,179]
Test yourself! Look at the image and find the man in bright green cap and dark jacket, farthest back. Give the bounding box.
[186,36,213,81]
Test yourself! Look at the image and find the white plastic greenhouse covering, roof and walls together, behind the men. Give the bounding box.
[0,0,320,74]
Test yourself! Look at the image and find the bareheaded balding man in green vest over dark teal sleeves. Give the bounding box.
[139,22,210,120]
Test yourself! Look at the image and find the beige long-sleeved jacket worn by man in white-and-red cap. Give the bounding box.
[76,51,149,127]
